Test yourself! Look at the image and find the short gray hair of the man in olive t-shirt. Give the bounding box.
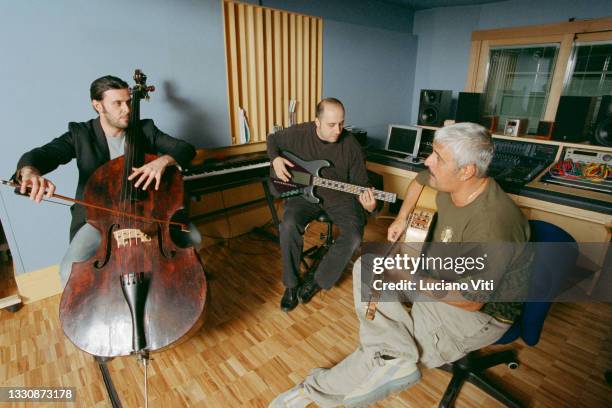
[434,122,493,177]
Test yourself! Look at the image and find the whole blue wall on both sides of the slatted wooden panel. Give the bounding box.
[0,0,416,273]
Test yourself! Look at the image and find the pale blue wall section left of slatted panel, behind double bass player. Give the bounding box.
[0,0,228,273]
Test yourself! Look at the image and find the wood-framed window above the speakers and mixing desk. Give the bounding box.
[465,17,612,143]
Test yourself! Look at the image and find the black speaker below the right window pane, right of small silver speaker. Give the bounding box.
[552,96,595,142]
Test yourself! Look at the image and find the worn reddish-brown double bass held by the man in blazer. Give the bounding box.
[59,70,207,358]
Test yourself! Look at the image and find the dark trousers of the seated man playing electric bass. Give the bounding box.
[279,197,365,289]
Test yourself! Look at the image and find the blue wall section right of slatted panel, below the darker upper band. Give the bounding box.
[323,21,416,147]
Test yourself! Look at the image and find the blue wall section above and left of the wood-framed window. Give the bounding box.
[411,0,612,123]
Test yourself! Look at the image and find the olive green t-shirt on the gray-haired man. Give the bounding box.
[416,170,530,323]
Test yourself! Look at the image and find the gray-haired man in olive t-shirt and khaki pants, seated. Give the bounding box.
[270,123,529,407]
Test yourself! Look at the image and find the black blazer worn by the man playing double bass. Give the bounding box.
[14,118,195,241]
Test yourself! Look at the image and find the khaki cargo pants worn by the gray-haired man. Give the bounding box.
[304,258,510,407]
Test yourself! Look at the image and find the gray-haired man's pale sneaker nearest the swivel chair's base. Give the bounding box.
[342,356,421,408]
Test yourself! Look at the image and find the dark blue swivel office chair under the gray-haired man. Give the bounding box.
[439,221,578,408]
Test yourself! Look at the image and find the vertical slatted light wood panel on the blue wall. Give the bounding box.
[223,0,323,144]
